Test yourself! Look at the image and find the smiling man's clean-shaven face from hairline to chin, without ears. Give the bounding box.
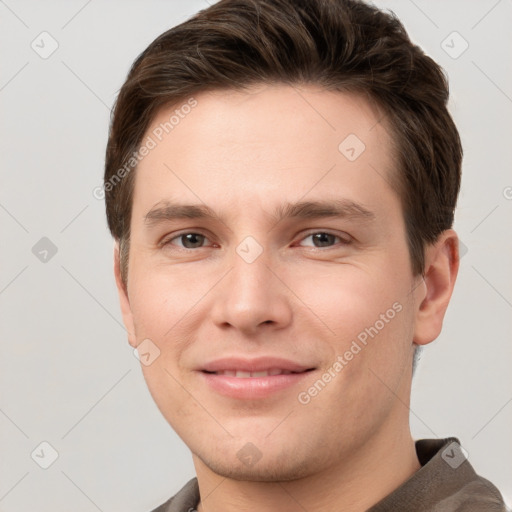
[116,85,419,480]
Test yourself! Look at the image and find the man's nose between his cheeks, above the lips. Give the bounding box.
[211,245,292,336]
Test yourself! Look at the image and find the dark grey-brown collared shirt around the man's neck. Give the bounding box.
[153,437,506,512]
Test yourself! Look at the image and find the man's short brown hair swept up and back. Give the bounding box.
[104,0,462,283]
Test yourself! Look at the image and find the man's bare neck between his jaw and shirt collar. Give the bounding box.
[194,422,420,512]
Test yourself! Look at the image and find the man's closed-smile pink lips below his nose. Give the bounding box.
[199,357,314,400]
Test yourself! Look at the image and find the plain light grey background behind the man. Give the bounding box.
[0,0,512,512]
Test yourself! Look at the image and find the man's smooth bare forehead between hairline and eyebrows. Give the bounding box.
[134,85,393,218]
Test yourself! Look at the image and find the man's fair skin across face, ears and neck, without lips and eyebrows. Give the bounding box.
[114,85,458,512]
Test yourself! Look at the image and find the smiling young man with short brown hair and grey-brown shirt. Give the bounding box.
[105,0,505,512]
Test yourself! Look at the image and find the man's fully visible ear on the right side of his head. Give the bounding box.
[413,229,459,345]
